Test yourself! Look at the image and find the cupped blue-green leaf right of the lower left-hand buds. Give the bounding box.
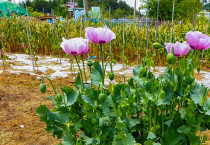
[61,87,78,106]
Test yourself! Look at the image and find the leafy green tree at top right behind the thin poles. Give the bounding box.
[144,0,202,20]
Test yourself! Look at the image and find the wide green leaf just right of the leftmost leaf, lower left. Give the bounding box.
[47,110,71,124]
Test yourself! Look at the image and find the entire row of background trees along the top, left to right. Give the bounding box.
[20,0,205,20]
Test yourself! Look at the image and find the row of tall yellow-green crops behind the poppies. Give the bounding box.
[0,16,210,64]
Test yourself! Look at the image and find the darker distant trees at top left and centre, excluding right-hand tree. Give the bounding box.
[20,0,137,18]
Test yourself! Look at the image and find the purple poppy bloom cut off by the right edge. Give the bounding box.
[186,31,210,50]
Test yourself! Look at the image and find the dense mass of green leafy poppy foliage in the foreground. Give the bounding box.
[36,56,210,145]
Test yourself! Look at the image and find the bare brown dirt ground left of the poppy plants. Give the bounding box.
[0,68,210,145]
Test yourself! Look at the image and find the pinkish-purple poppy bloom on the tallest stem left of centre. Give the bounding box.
[85,26,116,44]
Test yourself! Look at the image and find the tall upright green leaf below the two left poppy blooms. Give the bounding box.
[90,61,102,86]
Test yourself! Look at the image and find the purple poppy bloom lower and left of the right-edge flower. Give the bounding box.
[165,41,190,56]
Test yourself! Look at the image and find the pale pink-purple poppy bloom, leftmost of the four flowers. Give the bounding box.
[61,38,89,55]
